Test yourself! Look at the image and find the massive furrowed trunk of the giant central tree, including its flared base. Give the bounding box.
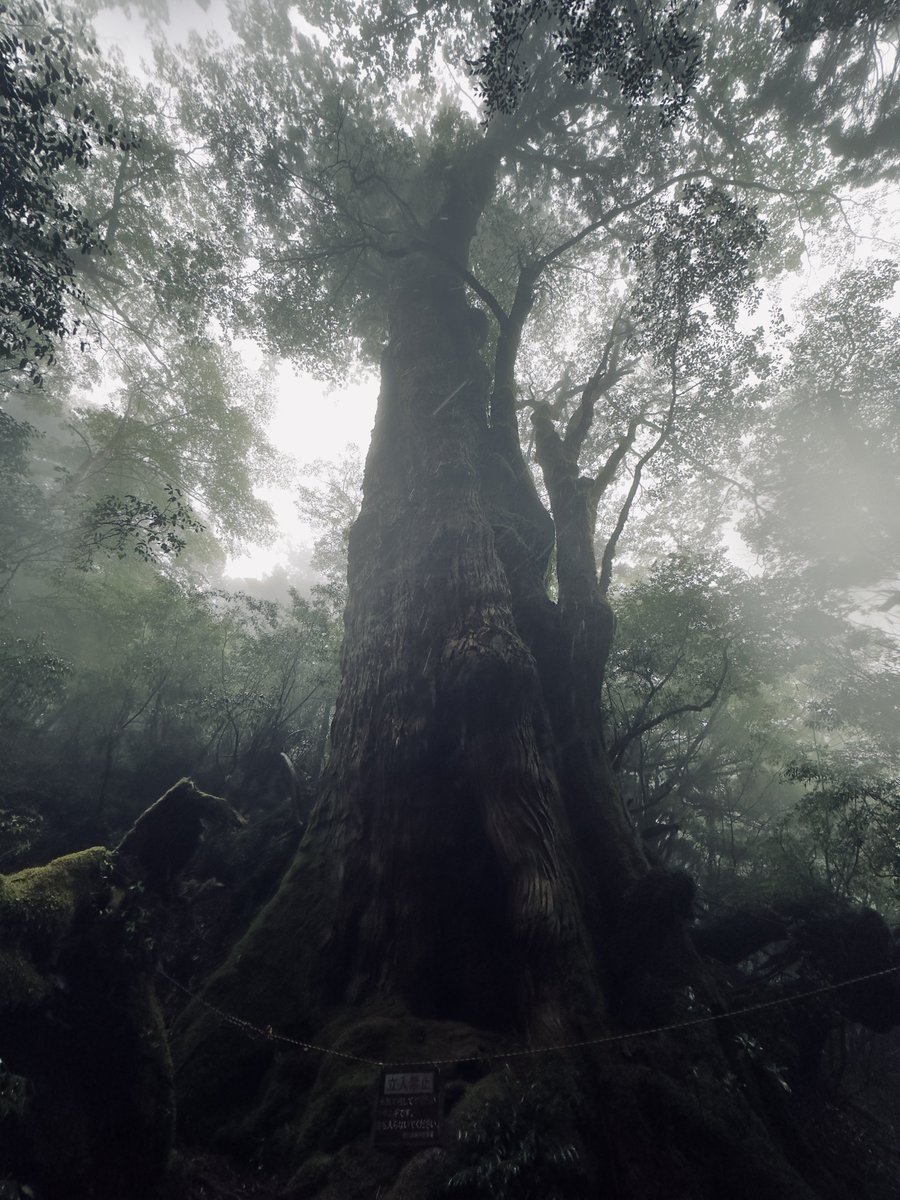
[168,133,859,1200]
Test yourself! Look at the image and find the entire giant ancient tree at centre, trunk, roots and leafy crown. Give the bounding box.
[169,4,893,1198]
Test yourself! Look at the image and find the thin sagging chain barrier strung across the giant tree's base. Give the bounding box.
[157,965,900,1069]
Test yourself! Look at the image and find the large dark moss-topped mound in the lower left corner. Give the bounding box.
[0,847,174,1200]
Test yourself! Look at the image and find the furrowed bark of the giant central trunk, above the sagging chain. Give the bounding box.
[174,133,647,1089]
